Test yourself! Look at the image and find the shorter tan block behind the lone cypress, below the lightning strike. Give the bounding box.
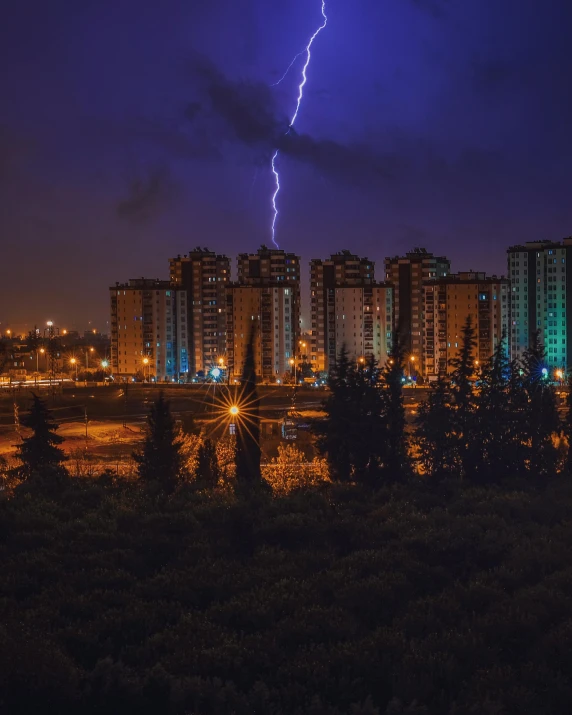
[226,283,298,382]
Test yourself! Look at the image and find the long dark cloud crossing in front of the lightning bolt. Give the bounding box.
[186,59,401,184]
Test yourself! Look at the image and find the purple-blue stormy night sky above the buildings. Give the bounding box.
[0,0,572,330]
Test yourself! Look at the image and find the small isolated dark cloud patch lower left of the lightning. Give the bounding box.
[116,166,178,223]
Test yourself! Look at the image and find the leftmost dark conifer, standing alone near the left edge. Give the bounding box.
[18,394,67,486]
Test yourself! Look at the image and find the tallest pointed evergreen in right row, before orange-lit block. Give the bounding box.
[451,316,479,479]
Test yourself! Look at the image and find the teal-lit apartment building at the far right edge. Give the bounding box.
[507,238,572,370]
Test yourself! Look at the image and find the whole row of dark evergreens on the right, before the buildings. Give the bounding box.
[318,320,572,486]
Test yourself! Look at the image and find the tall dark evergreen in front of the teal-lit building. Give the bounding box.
[522,331,560,476]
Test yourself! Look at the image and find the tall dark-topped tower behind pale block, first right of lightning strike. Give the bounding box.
[310,251,377,372]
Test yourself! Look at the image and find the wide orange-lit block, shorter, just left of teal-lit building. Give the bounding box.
[422,271,510,380]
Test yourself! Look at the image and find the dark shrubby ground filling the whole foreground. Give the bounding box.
[0,480,572,715]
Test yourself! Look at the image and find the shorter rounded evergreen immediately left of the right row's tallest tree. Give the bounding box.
[416,375,460,480]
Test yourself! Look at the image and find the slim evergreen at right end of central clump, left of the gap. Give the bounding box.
[380,333,410,481]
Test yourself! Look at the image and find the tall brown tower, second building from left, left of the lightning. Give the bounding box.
[169,248,230,378]
